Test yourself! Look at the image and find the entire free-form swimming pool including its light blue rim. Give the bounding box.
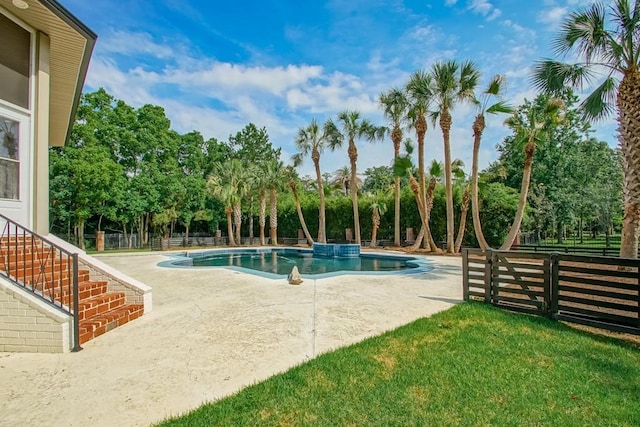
[160,248,432,278]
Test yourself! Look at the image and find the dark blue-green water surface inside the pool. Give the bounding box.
[192,249,418,275]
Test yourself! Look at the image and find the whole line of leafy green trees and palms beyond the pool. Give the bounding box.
[51,1,640,256]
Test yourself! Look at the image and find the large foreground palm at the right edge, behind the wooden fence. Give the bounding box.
[533,0,640,258]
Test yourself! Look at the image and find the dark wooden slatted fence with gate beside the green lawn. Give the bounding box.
[462,249,640,334]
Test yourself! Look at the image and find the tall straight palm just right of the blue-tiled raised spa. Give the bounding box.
[378,88,409,246]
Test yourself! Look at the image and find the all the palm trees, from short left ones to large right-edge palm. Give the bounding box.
[210,0,640,257]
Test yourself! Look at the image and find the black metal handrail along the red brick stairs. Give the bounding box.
[0,214,82,351]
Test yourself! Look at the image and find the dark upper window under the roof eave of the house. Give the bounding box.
[0,14,31,109]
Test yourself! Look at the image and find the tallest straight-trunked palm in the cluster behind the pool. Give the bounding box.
[431,61,480,253]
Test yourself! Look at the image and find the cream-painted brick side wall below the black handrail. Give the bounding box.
[0,279,71,353]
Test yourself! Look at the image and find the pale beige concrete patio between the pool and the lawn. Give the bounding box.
[0,254,462,426]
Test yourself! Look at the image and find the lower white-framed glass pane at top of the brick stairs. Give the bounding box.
[0,116,20,200]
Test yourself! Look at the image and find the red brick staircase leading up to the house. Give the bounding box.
[0,237,144,344]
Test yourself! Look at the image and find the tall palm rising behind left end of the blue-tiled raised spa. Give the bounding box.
[293,119,329,243]
